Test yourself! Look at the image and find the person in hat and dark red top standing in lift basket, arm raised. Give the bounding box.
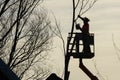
[76,15,91,53]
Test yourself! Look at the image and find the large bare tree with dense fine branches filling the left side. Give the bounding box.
[0,0,53,80]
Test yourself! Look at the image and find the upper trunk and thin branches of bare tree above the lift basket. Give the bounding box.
[71,0,97,36]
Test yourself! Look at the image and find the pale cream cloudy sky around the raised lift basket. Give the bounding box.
[44,0,120,80]
